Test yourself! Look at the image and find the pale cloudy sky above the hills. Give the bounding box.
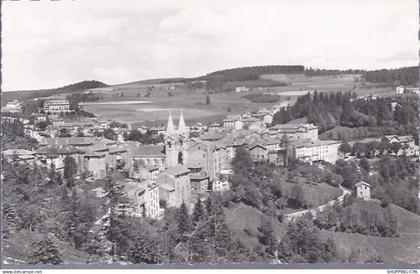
[1,0,419,91]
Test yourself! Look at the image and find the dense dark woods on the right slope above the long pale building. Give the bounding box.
[272,91,418,140]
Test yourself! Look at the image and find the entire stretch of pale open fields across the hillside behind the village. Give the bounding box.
[80,74,393,125]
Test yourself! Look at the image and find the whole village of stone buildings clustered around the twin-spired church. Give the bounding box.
[2,92,418,223]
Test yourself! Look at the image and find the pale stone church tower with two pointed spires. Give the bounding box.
[165,110,189,167]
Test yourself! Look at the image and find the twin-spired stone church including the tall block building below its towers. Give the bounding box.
[157,110,191,208]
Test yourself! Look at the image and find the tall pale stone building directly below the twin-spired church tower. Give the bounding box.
[157,166,191,207]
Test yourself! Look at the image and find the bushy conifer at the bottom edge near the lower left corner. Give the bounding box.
[28,237,63,265]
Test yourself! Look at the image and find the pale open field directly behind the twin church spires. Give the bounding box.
[83,84,273,125]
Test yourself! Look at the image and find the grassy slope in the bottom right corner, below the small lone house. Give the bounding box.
[321,205,420,264]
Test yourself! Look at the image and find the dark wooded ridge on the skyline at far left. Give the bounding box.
[1,80,108,105]
